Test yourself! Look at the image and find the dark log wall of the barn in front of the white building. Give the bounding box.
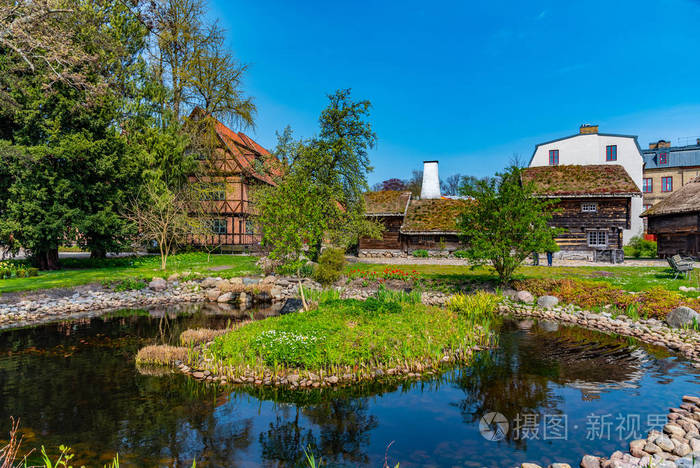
[550,197,630,251]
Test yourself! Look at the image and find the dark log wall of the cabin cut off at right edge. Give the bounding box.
[648,213,700,258]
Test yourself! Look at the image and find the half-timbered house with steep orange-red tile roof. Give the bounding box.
[190,113,283,251]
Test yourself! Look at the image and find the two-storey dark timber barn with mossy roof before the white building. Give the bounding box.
[522,164,642,262]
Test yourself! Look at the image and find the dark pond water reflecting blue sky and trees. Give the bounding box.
[0,305,700,468]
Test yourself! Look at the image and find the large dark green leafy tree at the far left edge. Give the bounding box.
[0,0,152,269]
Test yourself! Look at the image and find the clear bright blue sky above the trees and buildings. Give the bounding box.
[210,0,700,184]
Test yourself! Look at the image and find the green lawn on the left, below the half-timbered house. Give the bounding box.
[0,253,259,293]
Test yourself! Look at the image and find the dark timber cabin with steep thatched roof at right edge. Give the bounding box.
[642,177,700,258]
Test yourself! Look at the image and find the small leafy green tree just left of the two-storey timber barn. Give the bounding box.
[458,166,558,284]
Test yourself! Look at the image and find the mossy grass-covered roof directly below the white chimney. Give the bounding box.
[401,198,473,234]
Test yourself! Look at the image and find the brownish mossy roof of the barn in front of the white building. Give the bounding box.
[522,164,642,197]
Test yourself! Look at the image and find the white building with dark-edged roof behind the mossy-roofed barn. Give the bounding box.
[530,125,643,243]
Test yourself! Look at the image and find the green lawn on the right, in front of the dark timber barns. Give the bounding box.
[346,263,700,296]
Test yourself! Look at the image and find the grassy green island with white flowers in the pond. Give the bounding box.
[188,291,498,386]
